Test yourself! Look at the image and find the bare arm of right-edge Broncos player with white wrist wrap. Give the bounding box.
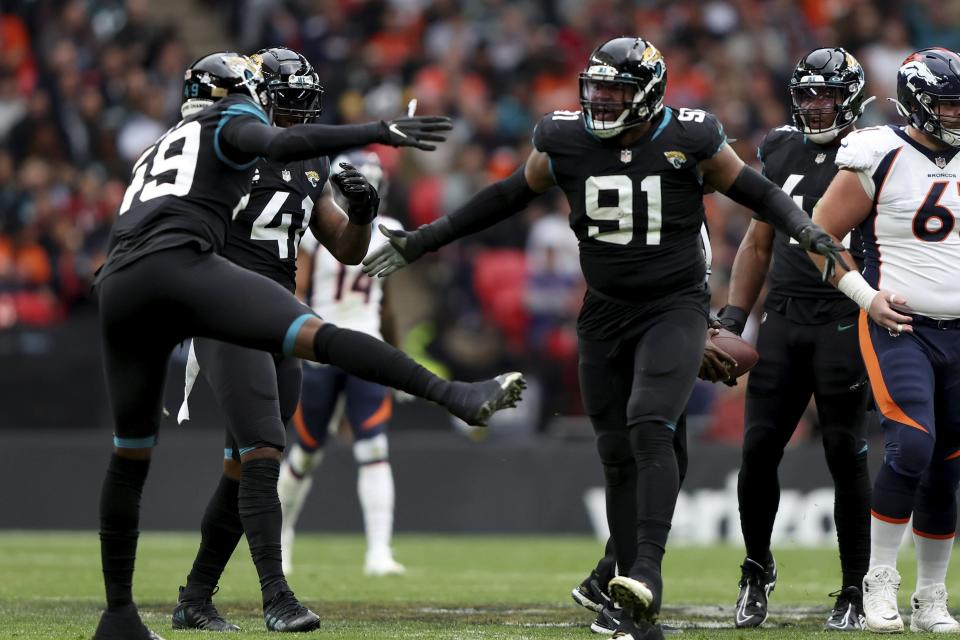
[810,169,913,333]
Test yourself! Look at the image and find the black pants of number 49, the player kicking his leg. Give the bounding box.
[99,247,314,448]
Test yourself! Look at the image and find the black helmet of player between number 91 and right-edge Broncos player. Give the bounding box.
[789,47,873,143]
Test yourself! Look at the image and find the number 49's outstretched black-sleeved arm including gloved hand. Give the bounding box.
[219,116,453,164]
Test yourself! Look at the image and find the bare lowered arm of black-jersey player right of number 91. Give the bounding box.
[720,220,774,335]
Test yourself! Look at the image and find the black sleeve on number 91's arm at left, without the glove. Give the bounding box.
[416,165,540,251]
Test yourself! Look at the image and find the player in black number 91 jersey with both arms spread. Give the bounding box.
[364,37,842,635]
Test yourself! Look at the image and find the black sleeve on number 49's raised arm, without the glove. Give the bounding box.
[220,117,386,163]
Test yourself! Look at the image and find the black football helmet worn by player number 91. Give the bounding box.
[580,37,667,138]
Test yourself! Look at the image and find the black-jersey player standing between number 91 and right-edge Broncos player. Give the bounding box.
[720,48,870,630]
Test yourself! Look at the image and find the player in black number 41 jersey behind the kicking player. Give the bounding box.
[173,48,379,631]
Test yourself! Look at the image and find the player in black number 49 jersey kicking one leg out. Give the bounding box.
[94,53,523,640]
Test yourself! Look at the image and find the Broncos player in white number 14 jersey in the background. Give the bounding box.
[277,151,406,576]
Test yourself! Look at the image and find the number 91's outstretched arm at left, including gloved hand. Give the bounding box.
[363,150,555,278]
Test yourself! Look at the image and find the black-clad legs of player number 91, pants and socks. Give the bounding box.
[579,308,707,608]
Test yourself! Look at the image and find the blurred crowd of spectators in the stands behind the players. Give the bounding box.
[0,0,960,436]
